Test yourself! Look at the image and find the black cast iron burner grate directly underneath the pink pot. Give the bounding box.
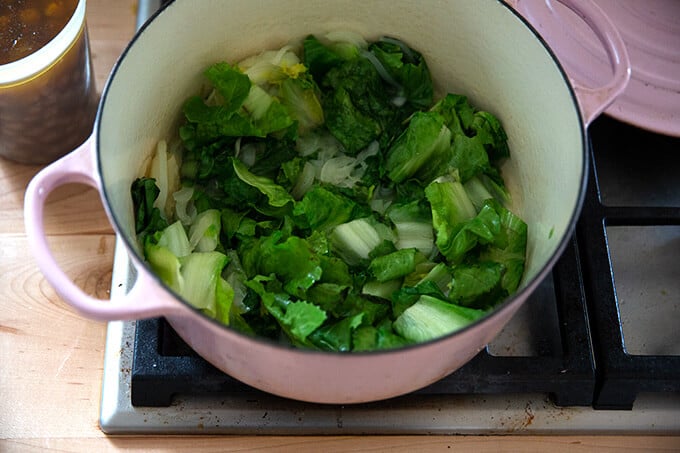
[131,231,595,406]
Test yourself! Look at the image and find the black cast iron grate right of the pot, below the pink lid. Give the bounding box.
[576,117,680,409]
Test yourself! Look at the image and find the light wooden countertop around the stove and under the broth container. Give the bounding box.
[0,0,680,452]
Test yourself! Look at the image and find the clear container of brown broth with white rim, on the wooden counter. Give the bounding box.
[0,0,98,164]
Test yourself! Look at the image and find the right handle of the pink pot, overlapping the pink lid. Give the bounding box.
[507,0,631,126]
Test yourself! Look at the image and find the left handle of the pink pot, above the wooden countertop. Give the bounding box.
[24,137,180,321]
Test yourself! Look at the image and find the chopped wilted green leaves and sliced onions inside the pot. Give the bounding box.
[132,33,527,351]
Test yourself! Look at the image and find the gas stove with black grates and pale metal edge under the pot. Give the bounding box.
[100,2,680,434]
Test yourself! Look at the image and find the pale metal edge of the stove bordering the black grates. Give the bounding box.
[100,239,680,435]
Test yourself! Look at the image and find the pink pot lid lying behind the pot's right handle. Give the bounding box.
[519,0,680,136]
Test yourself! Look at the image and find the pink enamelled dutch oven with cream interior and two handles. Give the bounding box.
[25,0,630,404]
